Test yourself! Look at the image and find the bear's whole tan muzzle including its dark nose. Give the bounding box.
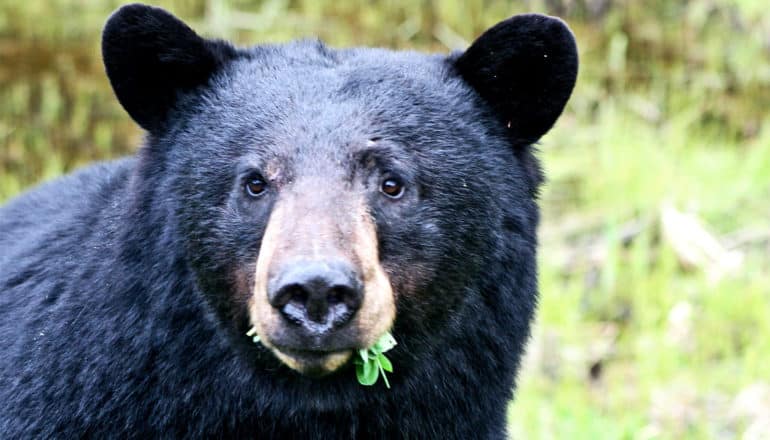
[249,188,395,376]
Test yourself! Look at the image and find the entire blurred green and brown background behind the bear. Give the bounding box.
[0,0,770,439]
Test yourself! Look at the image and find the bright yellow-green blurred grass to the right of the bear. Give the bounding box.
[510,102,770,438]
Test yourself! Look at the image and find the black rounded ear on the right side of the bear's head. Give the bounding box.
[455,14,578,144]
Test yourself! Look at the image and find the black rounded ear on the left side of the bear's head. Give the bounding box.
[102,4,236,132]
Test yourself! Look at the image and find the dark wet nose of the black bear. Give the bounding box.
[267,261,363,335]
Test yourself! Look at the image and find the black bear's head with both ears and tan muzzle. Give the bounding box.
[103,5,577,376]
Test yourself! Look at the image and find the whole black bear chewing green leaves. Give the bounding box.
[0,5,578,439]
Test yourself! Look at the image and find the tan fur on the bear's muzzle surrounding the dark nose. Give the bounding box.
[248,187,396,372]
